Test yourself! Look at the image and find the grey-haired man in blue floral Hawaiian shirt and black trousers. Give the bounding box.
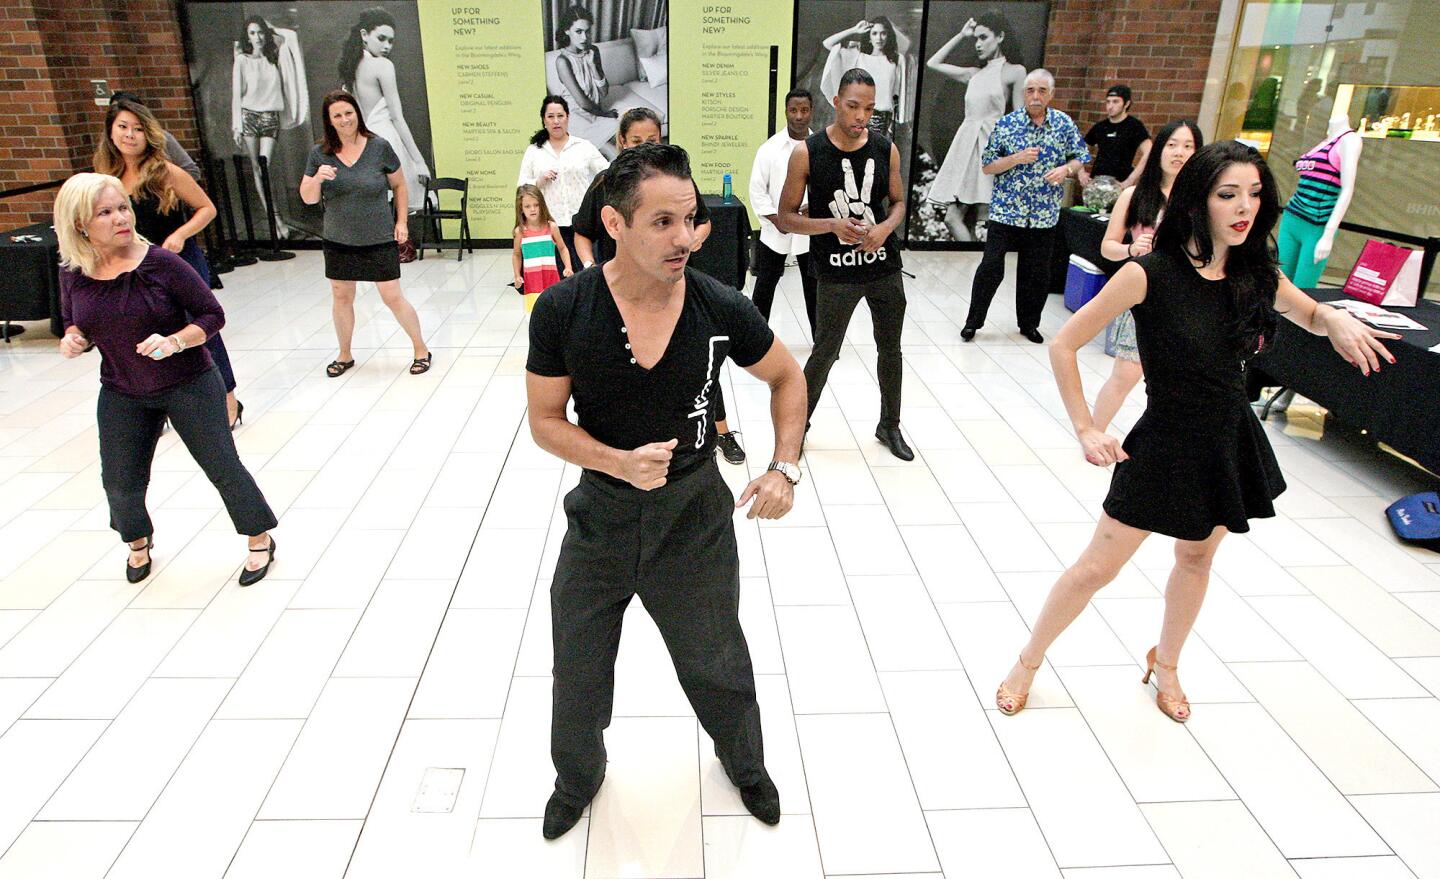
[960,69,1090,344]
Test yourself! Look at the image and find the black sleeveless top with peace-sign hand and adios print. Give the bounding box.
[805,128,900,284]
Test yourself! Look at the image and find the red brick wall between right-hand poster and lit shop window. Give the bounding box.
[1045,0,1220,134]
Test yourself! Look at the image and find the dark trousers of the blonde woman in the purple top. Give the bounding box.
[95,369,276,543]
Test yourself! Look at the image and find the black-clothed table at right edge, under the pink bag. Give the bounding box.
[1247,288,1440,473]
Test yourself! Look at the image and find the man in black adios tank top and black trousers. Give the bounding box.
[776,68,914,461]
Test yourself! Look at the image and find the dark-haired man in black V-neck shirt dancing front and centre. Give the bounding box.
[526,144,805,839]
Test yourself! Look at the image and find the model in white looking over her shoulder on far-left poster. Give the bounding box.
[338,6,431,210]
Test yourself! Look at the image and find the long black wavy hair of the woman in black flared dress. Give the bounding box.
[1152,140,1280,362]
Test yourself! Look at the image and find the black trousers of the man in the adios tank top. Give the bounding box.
[805,272,904,428]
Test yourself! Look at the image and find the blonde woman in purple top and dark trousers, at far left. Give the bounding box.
[55,174,276,586]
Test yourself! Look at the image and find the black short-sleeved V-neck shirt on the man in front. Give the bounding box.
[526,265,775,481]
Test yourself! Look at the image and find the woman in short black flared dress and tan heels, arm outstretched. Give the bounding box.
[995,141,1398,723]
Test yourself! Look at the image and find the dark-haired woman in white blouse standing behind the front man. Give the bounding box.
[517,95,611,272]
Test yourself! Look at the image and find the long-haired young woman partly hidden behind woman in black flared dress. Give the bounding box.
[1094,120,1205,431]
